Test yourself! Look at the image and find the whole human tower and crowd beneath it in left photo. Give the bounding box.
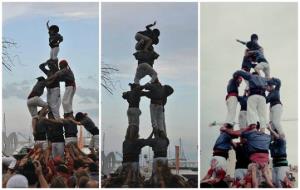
[2,21,99,188]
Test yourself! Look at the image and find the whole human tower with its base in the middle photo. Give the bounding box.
[102,22,195,187]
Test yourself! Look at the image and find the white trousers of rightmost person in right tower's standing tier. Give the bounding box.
[270,104,284,135]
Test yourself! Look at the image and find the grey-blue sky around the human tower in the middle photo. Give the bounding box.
[101,3,198,161]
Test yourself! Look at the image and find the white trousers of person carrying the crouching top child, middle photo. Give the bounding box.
[134,63,157,84]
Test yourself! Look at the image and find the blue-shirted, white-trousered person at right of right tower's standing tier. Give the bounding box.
[266,78,284,136]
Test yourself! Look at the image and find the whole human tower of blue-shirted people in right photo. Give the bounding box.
[201,34,293,188]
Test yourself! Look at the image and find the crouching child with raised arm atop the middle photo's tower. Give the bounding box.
[135,21,160,51]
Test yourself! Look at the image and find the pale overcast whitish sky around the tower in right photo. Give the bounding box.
[200,3,298,177]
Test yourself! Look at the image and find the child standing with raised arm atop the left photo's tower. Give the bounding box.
[47,21,63,60]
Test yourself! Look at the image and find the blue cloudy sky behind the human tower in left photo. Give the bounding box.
[2,2,99,140]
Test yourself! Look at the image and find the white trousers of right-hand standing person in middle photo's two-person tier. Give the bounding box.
[150,104,166,132]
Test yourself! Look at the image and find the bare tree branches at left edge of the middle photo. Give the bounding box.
[101,64,119,94]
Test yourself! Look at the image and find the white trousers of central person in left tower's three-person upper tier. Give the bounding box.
[47,87,61,119]
